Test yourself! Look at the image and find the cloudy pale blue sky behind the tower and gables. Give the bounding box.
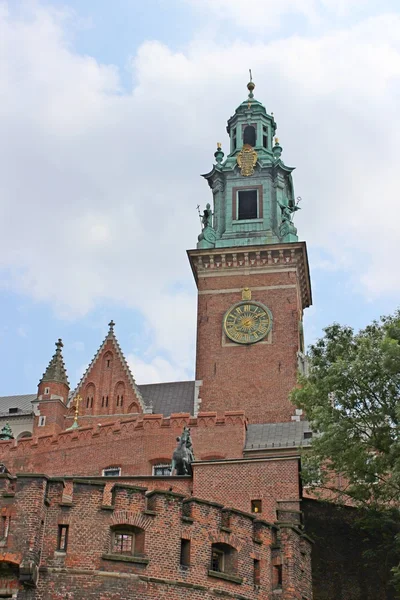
[0,0,400,395]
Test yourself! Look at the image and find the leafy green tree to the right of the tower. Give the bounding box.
[292,311,400,593]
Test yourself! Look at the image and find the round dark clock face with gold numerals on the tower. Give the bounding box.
[223,301,272,344]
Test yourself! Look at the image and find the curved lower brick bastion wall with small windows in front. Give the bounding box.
[0,475,311,600]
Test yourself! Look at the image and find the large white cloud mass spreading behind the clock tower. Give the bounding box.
[0,0,400,381]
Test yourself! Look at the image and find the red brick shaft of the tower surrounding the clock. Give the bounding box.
[192,246,303,423]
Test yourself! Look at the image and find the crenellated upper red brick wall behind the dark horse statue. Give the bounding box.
[0,410,246,475]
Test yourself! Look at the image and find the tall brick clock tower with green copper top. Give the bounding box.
[188,81,311,423]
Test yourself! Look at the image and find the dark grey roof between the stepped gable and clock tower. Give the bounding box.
[139,381,194,416]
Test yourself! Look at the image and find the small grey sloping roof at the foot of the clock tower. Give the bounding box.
[245,421,311,450]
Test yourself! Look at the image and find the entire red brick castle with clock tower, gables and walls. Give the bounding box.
[0,81,312,600]
